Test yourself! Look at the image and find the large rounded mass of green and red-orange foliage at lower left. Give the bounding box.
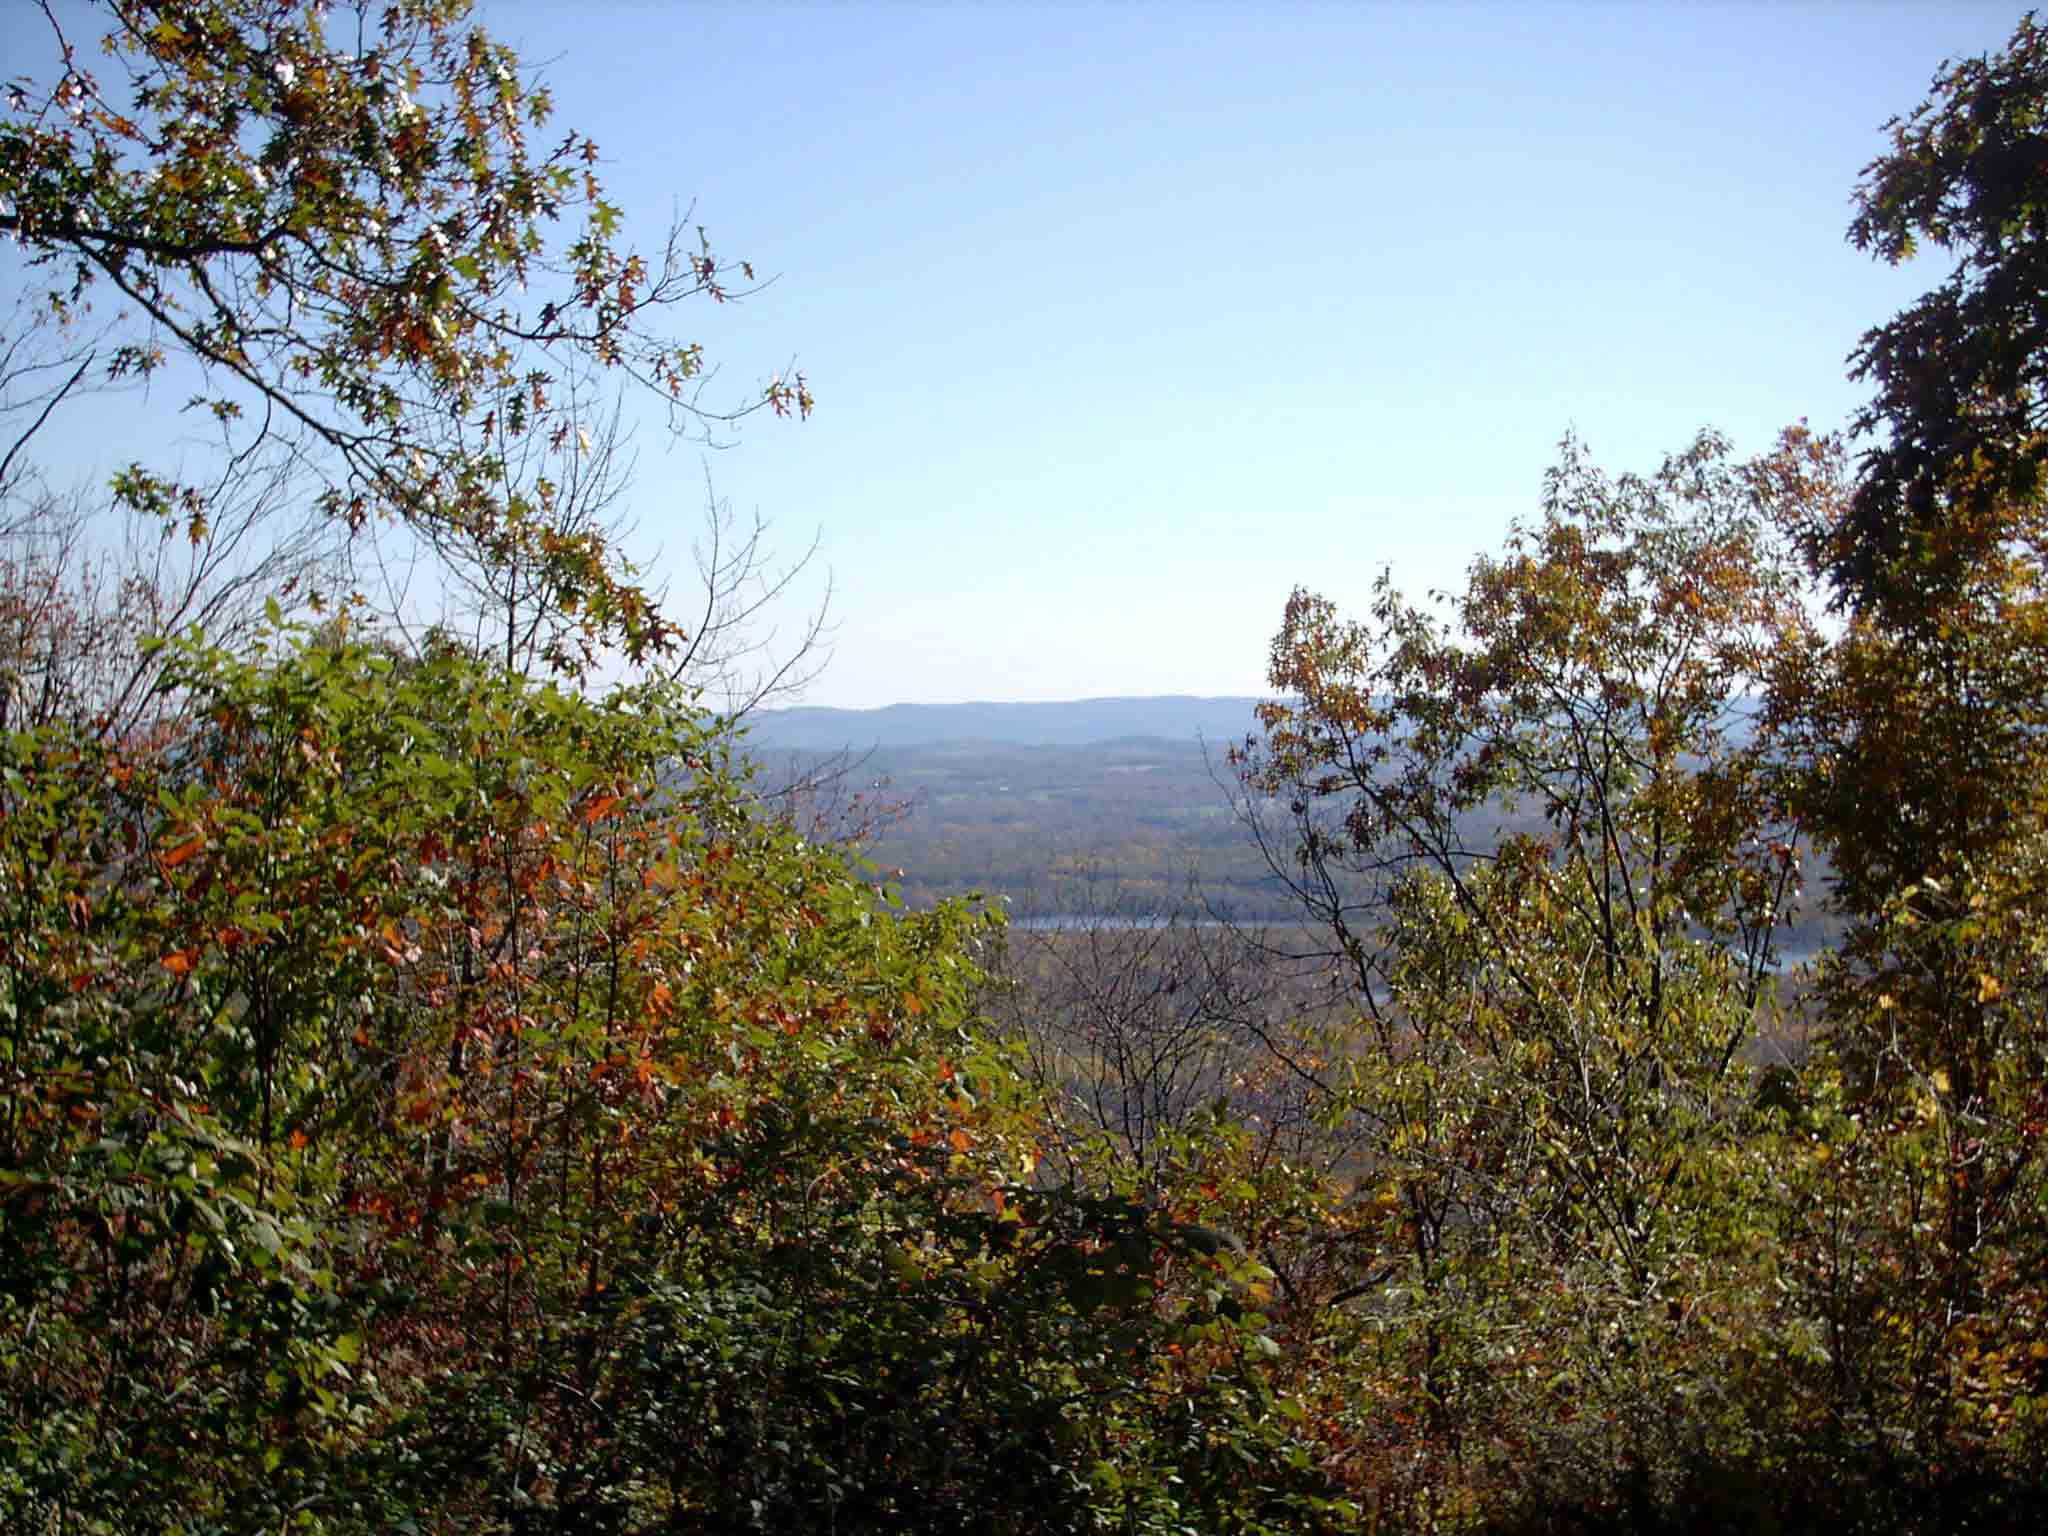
[0,631,1333,1532]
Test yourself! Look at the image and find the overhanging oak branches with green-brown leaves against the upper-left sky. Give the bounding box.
[0,0,811,655]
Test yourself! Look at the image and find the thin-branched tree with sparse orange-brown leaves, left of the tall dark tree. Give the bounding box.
[1237,436,1800,1048]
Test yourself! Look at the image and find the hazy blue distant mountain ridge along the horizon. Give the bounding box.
[745,694,1262,752]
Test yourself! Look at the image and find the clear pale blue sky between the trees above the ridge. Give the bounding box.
[8,0,2019,705]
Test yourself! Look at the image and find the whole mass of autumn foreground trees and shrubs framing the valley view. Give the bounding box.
[0,0,2048,1536]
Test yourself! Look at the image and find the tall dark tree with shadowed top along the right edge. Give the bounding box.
[1767,16,2048,1483]
